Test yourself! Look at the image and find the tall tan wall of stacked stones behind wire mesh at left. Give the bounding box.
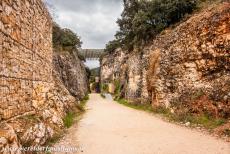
[0,0,53,120]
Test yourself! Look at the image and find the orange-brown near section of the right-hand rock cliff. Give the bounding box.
[148,2,230,117]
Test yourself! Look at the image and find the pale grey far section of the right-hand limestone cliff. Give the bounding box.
[101,48,149,103]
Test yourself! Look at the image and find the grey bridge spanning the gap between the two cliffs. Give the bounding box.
[79,49,104,59]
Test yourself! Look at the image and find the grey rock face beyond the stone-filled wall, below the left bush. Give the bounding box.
[53,51,88,99]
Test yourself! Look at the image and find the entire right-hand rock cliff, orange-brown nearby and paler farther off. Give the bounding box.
[101,2,230,118]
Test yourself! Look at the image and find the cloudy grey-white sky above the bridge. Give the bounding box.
[45,0,123,48]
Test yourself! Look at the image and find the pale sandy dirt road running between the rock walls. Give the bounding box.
[56,94,230,154]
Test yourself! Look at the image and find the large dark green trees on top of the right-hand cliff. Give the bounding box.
[106,0,198,52]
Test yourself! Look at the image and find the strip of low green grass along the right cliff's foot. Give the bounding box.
[116,99,226,129]
